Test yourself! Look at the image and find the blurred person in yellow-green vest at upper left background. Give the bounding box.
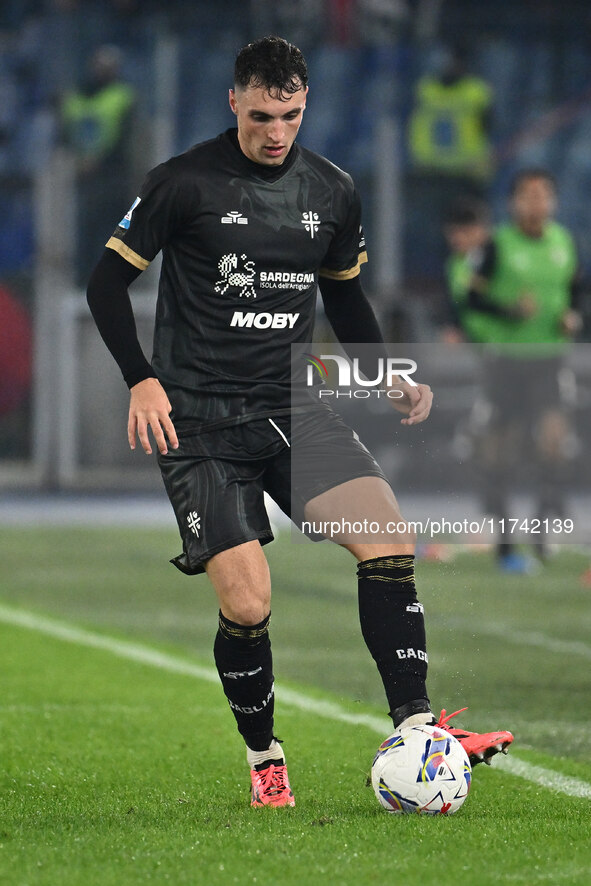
[60,45,135,285]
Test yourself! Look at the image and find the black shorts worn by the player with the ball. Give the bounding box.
[158,407,387,575]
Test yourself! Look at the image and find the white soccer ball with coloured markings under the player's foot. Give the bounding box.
[371,726,472,815]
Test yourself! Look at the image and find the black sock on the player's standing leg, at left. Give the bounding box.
[213,612,275,751]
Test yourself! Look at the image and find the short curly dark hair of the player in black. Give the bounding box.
[234,37,308,98]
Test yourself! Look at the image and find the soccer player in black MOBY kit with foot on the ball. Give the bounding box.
[88,37,512,806]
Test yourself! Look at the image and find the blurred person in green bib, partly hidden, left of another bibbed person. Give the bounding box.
[441,197,491,343]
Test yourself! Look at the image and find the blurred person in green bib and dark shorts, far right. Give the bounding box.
[448,168,581,572]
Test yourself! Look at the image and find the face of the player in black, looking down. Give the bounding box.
[230,86,308,166]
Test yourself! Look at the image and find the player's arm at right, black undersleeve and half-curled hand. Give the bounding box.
[318,275,433,425]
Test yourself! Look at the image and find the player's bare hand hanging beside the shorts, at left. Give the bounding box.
[127,378,179,455]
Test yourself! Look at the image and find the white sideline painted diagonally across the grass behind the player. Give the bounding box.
[0,604,591,800]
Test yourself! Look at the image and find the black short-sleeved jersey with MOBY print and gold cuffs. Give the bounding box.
[107,130,367,430]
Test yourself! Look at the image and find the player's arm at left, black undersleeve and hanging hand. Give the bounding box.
[87,249,178,455]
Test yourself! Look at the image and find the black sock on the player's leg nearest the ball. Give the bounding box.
[357,555,429,716]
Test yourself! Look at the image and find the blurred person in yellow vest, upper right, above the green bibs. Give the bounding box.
[406,47,493,277]
